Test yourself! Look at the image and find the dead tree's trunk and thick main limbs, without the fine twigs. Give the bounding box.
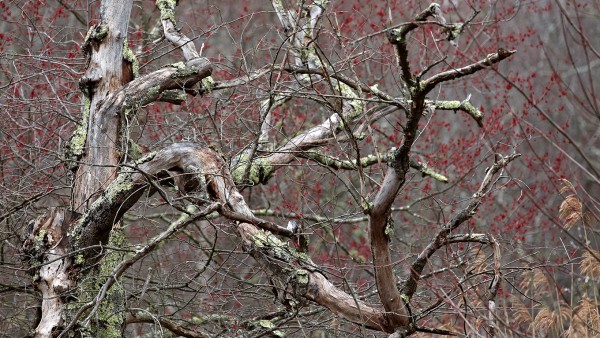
[18,0,514,338]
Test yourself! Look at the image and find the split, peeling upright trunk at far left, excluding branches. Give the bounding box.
[34,0,132,337]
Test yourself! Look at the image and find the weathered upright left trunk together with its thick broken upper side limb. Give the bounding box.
[24,0,211,338]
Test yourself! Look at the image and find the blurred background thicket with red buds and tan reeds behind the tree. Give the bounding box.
[0,0,600,337]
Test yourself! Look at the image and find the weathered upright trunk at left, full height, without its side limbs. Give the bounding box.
[26,0,133,338]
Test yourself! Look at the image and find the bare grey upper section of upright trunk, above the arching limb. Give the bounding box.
[72,0,132,212]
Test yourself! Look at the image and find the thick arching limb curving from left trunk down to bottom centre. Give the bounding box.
[56,142,408,332]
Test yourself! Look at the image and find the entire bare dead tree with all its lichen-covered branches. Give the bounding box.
[1,0,519,337]
